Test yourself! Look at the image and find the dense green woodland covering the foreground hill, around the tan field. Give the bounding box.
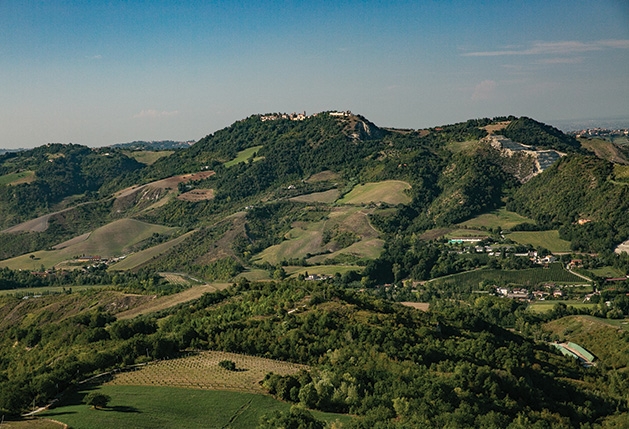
[0,281,629,428]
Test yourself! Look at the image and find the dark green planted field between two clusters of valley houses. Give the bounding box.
[430,264,584,290]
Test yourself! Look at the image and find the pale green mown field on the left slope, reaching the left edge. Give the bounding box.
[0,219,173,270]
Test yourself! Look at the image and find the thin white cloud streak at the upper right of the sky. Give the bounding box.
[462,39,629,57]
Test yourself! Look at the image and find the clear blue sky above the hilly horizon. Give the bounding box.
[0,0,629,148]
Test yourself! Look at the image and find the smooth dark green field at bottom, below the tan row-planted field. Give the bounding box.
[42,385,350,429]
